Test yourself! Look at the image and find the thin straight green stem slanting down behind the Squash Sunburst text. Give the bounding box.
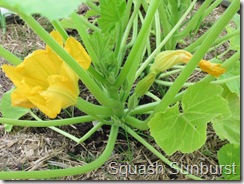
[122,125,202,180]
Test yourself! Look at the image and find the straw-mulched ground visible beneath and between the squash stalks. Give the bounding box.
[0,4,236,180]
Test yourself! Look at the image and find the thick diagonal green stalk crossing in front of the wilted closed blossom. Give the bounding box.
[146,0,240,122]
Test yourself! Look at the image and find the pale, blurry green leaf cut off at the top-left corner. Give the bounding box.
[0,0,85,20]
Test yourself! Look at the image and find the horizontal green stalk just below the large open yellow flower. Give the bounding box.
[0,116,101,127]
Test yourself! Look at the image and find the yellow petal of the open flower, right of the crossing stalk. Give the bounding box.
[65,37,91,70]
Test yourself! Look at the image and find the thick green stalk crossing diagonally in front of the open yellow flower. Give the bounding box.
[18,12,114,107]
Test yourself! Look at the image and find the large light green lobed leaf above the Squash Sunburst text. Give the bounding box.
[148,83,230,155]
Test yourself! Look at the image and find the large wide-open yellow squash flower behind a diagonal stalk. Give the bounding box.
[2,31,91,118]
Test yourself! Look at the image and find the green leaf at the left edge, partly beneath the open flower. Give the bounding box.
[0,90,29,132]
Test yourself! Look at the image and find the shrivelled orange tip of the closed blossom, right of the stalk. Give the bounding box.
[198,60,226,77]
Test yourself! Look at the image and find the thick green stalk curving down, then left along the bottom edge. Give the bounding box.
[0,126,118,180]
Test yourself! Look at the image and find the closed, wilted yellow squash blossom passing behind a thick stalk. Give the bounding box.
[150,50,226,77]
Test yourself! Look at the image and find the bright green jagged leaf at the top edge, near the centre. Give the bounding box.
[98,0,126,33]
